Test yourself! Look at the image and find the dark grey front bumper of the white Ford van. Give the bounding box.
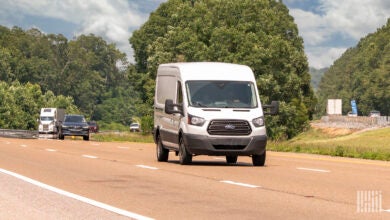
[183,134,267,156]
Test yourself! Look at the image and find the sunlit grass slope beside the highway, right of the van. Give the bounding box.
[267,127,390,161]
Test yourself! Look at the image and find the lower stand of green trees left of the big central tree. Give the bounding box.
[0,26,140,129]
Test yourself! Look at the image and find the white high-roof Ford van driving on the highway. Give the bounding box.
[153,62,279,166]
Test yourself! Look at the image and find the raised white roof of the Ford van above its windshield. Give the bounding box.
[158,62,255,81]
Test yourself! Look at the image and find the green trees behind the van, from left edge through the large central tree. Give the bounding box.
[0,0,316,139]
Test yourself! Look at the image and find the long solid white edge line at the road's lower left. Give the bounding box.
[0,168,152,220]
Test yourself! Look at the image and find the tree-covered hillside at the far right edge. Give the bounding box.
[318,19,390,115]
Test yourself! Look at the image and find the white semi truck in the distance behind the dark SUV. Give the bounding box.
[38,108,65,138]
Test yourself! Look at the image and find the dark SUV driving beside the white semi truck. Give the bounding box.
[58,115,89,141]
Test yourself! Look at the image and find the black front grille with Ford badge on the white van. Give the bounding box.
[207,120,252,135]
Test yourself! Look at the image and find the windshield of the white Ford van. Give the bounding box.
[186,80,257,108]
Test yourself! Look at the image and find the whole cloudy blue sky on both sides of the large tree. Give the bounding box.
[0,0,390,69]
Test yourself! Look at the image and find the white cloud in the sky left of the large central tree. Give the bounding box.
[0,0,147,61]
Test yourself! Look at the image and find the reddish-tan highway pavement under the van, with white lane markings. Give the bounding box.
[0,138,390,220]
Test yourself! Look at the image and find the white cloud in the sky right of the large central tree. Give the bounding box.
[287,0,390,68]
